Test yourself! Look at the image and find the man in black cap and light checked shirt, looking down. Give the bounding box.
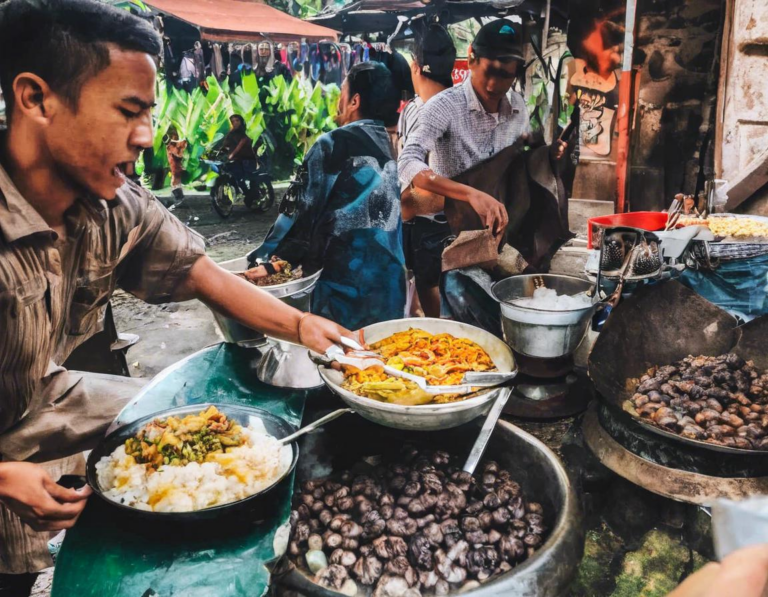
[398,19,566,237]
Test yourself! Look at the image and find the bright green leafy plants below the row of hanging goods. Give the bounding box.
[145,73,339,185]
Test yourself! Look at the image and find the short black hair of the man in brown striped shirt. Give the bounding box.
[0,0,163,123]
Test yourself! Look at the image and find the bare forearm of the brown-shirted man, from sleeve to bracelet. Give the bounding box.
[184,257,302,342]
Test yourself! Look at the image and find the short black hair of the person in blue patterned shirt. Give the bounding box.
[347,61,400,126]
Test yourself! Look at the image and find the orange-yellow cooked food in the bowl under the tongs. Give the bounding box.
[342,328,496,405]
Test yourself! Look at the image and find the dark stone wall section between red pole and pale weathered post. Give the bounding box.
[628,0,724,211]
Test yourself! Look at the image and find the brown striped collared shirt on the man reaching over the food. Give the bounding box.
[0,161,205,454]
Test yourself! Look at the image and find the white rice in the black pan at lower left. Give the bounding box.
[96,425,293,512]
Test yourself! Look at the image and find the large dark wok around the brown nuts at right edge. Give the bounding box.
[589,280,768,477]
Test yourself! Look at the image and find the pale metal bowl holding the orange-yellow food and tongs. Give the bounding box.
[318,317,517,431]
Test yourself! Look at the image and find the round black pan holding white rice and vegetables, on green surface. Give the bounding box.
[86,403,299,523]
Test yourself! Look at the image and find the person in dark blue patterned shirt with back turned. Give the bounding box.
[249,62,406,330]
